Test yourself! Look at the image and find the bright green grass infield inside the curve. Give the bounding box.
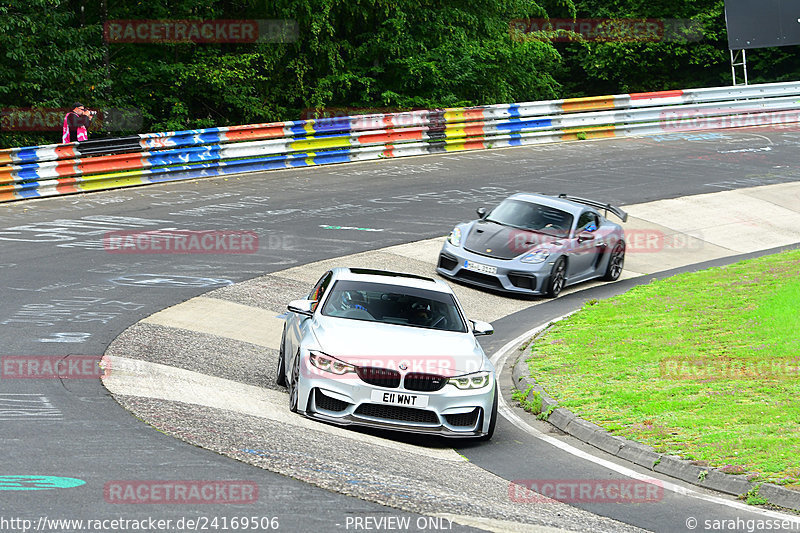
[526,250,800,489]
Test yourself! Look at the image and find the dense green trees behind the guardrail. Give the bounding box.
[0,0,800,146]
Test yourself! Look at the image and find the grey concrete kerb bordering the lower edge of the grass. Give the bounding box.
[511,350,800,511]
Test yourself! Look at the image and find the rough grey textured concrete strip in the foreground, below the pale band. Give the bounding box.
[116,396,642,532]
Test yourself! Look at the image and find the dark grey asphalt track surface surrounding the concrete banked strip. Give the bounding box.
[0,128,800,531]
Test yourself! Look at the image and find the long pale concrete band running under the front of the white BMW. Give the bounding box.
[103,356,467,462]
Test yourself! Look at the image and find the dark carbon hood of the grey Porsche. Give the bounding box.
[464,220,560,259]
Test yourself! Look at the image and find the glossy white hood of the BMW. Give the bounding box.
[313,315,492,376]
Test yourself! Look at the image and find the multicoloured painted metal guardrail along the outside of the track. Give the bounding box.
[0,82,800,202]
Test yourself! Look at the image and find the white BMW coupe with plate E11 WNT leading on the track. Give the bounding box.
[276,268,497,440]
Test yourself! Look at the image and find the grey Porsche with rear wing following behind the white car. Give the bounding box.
[436,193,628,298]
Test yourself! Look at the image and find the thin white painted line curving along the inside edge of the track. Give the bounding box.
[490,326,800,524]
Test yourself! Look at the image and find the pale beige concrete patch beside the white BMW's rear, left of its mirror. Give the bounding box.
[142,296,284,350]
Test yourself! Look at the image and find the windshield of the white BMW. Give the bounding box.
[322,280,467,333]
